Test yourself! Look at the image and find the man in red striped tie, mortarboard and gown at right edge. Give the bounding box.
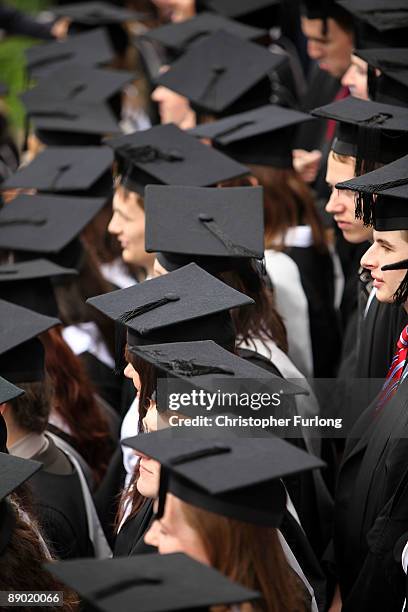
[324,157,408,612]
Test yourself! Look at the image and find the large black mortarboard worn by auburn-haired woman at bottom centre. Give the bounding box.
[124,426,324,527]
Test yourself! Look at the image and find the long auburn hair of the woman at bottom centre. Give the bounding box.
[179,499,310,612]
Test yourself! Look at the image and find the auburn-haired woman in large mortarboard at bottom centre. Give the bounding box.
[126,428,324,612]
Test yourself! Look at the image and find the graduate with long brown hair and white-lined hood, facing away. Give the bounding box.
[192,105,339,377]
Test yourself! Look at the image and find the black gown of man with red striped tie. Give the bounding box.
[334,381,408,612]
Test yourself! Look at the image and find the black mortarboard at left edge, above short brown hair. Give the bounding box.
[0,300,60,383]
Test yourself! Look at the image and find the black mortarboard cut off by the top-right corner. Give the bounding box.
[337,0,408,48]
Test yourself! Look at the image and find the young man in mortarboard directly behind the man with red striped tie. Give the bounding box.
[313,97,408,390]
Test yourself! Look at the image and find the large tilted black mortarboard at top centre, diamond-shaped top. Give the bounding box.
[156,32,286,115]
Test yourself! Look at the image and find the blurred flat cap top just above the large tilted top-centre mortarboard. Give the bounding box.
[144,13,267,54]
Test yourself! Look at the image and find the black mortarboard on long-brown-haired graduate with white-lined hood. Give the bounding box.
[190,104,313,168]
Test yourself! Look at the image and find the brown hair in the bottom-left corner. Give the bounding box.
[0,500,79,612]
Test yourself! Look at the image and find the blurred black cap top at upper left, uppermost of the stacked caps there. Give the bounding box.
[25,28,114,79]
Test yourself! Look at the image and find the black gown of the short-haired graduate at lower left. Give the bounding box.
[30,438,94,559]
